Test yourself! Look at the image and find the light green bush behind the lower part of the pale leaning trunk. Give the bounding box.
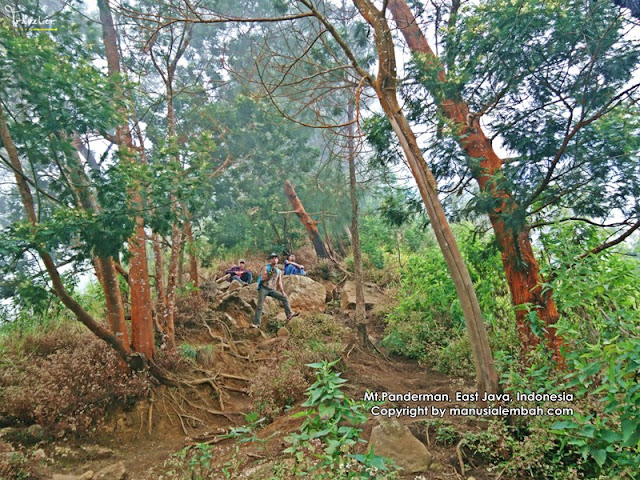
[384,226,517,376]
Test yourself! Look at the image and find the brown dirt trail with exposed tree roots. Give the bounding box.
[12,282,498,480]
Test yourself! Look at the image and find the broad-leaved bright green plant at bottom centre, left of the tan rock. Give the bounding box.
[285,360,392,478]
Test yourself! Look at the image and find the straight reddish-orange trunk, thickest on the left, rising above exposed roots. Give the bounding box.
[98,0,155,359]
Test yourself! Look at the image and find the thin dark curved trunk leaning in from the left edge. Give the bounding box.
[0,102,131,360]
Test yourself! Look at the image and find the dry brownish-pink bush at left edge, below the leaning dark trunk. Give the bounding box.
[0,333,148,433]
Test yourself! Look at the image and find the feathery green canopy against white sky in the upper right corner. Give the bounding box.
[402,0,640,232]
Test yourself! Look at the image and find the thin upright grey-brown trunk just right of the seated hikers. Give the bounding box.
[347,100,369,348]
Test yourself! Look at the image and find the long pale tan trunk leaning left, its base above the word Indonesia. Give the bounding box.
[353,0,499,398]
